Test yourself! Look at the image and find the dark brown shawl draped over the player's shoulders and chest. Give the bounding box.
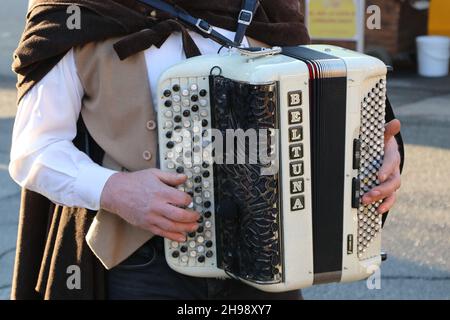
[12,0,309,101]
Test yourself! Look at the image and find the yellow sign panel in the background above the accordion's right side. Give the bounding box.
[307,0,358,39]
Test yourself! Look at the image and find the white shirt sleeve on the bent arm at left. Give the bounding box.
[9,50,115,210]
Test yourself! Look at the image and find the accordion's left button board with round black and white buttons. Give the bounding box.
[159,77,216,267]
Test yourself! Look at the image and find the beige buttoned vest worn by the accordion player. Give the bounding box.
[75,38,263,269]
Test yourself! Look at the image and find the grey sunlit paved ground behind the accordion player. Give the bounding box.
[0,0,450,299]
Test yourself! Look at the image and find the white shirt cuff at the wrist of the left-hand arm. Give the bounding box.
[74,163,117,211]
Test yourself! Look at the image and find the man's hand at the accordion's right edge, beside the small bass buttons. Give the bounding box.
[363,120,401,214]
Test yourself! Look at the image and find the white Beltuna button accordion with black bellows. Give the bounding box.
[158,45,387,292]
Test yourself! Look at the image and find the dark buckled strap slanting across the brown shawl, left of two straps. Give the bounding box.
[137,0,239,47]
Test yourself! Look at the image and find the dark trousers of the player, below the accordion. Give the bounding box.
[107,237,302,300]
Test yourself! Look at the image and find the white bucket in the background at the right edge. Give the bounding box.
[417,36,450,77]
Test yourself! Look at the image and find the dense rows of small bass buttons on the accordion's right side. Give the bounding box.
[358,79,386,259]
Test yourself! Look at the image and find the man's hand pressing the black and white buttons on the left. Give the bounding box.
[101,169,200,242]
